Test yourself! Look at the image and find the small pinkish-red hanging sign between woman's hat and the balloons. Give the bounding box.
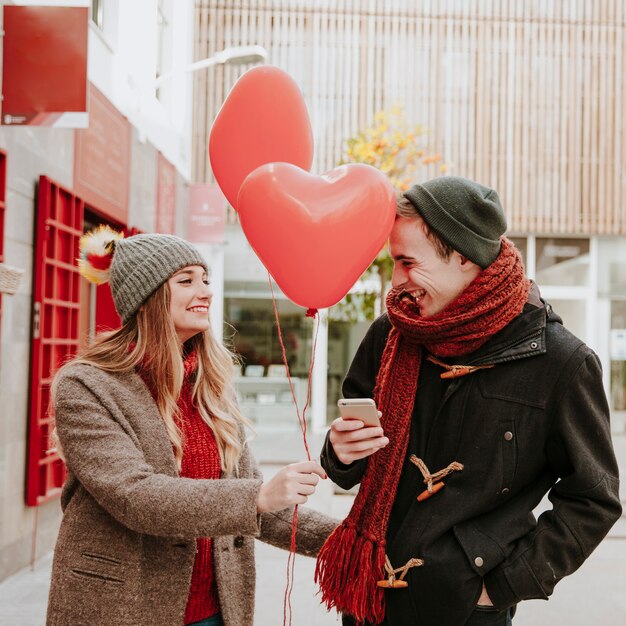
[187,183,228,243]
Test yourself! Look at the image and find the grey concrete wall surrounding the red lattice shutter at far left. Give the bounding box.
[0,127,74,580]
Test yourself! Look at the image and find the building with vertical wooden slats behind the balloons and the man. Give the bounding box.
[193,0,626,428]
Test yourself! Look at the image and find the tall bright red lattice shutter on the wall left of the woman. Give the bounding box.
[26,176,84,506]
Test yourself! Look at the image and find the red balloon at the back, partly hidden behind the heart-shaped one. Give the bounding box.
[209,65,313,209]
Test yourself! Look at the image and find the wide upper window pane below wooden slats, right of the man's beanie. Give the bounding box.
[536,237,589,287]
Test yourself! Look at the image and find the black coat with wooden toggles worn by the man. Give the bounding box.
[321,286,622,626]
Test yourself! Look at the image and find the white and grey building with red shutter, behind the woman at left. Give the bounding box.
[0,0,193,580]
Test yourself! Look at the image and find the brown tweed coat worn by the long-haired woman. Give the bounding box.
[47,365,336,626]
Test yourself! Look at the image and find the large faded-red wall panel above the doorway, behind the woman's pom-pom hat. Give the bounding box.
[74,84,131,224]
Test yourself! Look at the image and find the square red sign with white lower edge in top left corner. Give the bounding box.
[2,6,88,128]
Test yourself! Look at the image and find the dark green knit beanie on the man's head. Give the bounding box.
[404,176,506,268]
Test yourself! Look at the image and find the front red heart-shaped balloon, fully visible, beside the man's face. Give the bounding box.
[237,163,396,309]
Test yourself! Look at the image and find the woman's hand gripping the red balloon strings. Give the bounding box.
[256,461,326,513]
